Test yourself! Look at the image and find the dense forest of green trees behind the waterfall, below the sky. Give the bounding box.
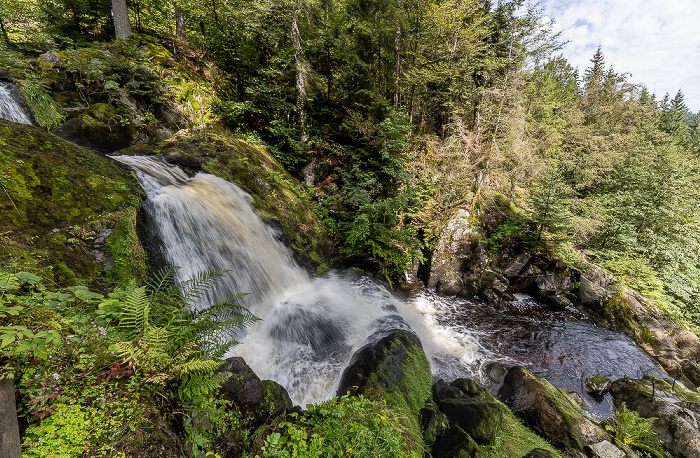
[0,0,700,323]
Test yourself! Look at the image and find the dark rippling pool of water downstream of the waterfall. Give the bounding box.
[416,293,668,418]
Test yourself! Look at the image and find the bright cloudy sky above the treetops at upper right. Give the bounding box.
[540,0,700,113]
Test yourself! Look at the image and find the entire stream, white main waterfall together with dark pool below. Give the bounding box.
[115,156,664,417]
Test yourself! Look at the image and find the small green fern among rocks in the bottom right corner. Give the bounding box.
[605,403,669,458]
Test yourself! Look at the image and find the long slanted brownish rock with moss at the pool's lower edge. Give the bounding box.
[498,367,608,450]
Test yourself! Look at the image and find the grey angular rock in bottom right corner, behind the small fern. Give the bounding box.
[610,377,700,458]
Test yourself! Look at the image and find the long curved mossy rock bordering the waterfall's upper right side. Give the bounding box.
[119,129,331,271]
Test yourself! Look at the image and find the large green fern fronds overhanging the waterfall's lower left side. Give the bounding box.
[100,268,257,455]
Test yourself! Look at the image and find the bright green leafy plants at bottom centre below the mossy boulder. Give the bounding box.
[263,395,416,457]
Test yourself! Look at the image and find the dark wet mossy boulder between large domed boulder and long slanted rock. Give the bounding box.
[433,378,507,445]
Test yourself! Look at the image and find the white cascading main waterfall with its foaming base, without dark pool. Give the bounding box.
[114,156,478,405]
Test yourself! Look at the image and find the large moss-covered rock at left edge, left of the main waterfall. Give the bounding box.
[0,120,146,285]
